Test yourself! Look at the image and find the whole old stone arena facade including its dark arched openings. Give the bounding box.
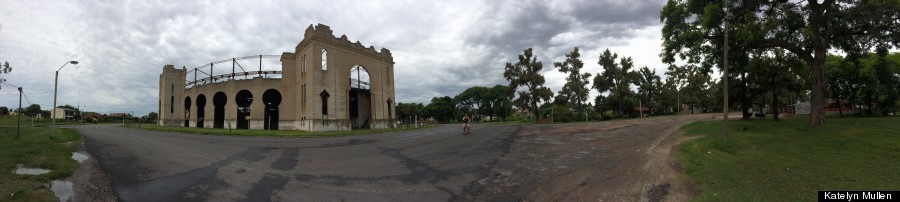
[159,24,396,131]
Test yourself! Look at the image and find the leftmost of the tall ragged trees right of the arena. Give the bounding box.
[503,48,553,120]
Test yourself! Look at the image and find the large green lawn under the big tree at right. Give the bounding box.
[676,116,900,201]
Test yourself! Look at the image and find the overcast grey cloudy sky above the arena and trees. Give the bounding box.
[0,0,665,115]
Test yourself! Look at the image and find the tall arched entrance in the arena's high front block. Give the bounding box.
[347,65,372,129]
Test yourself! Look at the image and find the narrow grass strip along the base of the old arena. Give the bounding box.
[128,124,437,137]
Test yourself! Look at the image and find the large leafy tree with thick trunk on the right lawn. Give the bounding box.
[660,0,900,126]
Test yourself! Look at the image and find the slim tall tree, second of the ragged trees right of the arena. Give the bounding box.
[553,47,591,119]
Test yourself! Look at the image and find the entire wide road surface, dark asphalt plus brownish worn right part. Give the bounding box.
[74,115,709,201]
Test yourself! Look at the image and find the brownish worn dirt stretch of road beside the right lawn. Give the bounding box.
[459,114,711,201]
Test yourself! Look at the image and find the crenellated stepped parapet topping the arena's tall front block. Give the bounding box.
[296,24,394,64]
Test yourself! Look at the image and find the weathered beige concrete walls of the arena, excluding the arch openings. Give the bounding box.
[159,24,396,131]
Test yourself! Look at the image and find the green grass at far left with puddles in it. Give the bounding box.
[0,124,81,201]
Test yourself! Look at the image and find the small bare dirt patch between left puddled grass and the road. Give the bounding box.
[71,141,118,201]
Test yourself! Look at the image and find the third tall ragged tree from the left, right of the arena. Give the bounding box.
[593,49,638,115]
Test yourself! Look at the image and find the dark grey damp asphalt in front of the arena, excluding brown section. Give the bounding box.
[74,124,521,201]
